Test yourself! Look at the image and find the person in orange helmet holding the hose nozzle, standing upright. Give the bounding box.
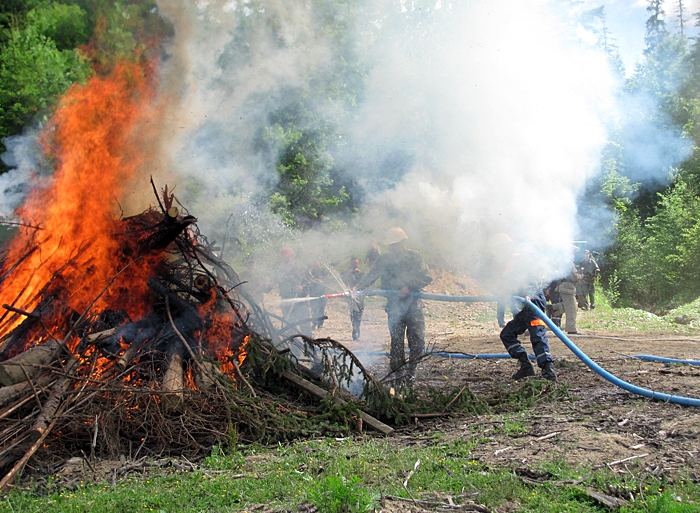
[356,227,433,378]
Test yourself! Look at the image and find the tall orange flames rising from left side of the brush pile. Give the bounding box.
[0,63,155,344]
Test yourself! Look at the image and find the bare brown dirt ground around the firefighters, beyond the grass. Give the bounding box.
[296,275,700,476]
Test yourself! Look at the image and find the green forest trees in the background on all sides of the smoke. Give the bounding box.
[0,0,700,312]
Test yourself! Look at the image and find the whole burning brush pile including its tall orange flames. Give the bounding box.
[0,63,391,489]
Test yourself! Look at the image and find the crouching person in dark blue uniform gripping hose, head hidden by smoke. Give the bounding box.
[490,233,557,381]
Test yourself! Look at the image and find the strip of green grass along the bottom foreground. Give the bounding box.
[5,436,700,513]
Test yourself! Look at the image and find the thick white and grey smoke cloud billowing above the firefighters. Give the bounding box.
[0,0,688,292]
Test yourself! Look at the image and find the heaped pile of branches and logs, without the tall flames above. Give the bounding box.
[0,186,390,488]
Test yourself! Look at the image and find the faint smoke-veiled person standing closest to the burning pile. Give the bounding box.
[277,247,311,337]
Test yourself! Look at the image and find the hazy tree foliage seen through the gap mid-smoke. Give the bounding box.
[254,0,369,229]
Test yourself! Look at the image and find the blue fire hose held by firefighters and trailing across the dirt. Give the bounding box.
[358,290,700,407]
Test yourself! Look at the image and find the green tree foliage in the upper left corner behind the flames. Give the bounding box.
[0,0,171,172]
